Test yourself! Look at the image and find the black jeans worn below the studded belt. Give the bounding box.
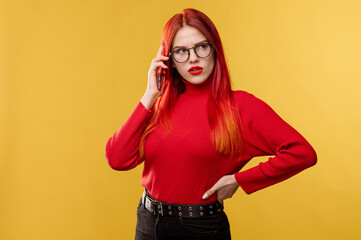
[135,196,231,240]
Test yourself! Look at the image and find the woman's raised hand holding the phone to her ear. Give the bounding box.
[147,46,169,98]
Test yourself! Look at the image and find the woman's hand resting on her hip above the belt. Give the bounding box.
[202,174,239,204]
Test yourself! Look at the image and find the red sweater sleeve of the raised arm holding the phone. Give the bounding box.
[105,101,152,170]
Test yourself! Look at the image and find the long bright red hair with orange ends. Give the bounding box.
[139,8,242,160]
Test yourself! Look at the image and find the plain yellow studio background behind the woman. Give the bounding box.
[0,0,361,240]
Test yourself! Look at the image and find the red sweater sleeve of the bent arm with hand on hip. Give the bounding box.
[235,92,317,194]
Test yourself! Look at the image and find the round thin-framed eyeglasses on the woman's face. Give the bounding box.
[170,43,213,63]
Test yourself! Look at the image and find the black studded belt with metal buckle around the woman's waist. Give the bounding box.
[142,190,223,217]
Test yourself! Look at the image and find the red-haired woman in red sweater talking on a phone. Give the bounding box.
[106,9,317,239]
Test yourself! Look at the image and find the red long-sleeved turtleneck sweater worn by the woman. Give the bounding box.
[105,81,317,204]
